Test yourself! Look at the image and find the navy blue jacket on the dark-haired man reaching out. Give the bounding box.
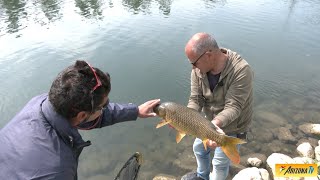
[0,94,138,180]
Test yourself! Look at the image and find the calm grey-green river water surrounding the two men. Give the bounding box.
[0,0,320,179]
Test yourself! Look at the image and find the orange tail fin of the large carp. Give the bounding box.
[221,136,246,164]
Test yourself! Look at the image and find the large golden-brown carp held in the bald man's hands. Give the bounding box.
[153,102,246,164]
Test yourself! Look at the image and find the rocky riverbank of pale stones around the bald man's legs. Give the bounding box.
[153,123,320,180]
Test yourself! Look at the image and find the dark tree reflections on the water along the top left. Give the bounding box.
[0,0,178,37]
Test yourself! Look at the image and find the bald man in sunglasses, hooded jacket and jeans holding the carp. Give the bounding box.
[182,33,253,180]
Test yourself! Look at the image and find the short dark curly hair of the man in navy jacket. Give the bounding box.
[49,60,111,119]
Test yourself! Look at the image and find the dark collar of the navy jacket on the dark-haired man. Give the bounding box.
[41,97,91,149]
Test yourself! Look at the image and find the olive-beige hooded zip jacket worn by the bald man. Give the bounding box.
[188,48,253,134]
